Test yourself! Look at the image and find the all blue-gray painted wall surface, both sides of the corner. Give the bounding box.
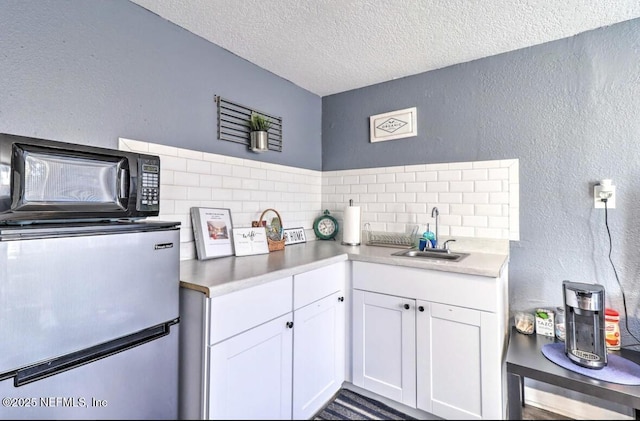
[0,0,640,344]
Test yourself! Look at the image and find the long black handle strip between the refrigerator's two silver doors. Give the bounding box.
[0,318,180,387]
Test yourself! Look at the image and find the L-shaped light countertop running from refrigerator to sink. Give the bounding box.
[180,241,509,297]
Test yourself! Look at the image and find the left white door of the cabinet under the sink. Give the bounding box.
[353,288,416,408]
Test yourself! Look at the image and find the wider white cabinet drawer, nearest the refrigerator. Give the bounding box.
[209,276,293,345]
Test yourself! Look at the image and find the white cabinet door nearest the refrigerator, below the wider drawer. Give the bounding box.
[208,313,293,420]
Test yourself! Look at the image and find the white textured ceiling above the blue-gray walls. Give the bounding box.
[132,0,640,96]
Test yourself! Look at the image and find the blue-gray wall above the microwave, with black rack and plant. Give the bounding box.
[0,0,322,170]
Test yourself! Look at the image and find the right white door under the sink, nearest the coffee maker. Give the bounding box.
[416,301,492,420]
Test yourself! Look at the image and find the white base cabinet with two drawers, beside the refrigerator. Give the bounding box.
[179,262,347,420]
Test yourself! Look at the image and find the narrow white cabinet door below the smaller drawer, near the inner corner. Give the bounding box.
[293,291,345,420]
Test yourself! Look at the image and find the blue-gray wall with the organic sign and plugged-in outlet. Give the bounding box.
[322,19,640,345]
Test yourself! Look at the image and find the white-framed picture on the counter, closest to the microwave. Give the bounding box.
[191,208,234,260]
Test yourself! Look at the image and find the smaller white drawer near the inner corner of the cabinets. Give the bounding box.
[293,262,346,309]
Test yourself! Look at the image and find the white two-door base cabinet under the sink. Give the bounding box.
[353,262,508,419]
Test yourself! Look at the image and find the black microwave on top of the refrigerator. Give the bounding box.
[0,133,160,224]
